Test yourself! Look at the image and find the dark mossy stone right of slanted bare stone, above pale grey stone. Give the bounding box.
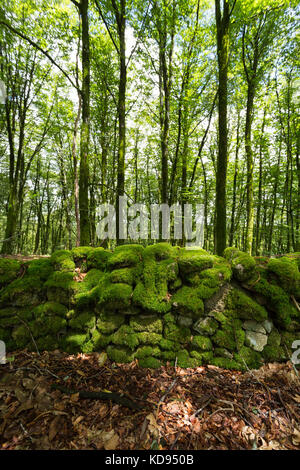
[226,289,268,322]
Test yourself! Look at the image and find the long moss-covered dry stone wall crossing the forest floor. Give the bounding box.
[0,243,300,370]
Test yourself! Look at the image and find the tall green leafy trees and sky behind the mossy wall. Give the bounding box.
[0,0,300,255]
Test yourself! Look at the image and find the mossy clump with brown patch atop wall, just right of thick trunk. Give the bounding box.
[224,247,256,282]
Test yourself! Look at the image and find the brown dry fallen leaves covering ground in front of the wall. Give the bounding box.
[0,351,300,450]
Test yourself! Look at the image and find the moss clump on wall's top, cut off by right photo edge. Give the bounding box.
[267,256,300,297]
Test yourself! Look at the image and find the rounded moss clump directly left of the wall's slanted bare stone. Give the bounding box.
[172,286,204,319]
